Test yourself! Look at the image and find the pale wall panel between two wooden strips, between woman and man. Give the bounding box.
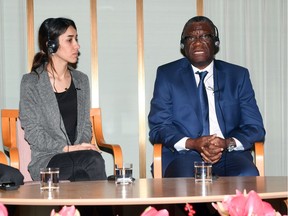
[97,0,139,178]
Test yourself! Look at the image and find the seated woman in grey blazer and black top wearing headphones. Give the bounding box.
[20,18,106,181]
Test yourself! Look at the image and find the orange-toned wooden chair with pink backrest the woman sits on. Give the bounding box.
[0,108,123,182]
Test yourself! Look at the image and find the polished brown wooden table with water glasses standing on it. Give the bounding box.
[0,176,288,206]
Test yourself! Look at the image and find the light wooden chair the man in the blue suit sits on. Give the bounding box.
[153,142,264,178]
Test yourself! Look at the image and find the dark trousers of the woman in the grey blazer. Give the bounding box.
[47,150,107,182]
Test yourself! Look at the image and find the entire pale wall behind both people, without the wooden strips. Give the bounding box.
[0,0,288,178]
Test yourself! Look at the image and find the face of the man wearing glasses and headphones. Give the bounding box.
[183,22,215,69]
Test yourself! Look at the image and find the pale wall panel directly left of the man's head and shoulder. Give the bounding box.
[144,0,197,177]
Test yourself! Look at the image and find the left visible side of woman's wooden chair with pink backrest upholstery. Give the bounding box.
[1,109,32,182]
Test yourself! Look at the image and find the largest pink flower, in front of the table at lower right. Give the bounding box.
[212,190,279,216]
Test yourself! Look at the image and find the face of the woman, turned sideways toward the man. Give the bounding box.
[53,26,80,63]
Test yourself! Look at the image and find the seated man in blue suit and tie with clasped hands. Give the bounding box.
[148,16,265,177]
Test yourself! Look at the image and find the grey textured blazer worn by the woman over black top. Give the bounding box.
[19,67,92,180]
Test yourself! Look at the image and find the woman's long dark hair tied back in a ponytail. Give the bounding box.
[31,17,77,72]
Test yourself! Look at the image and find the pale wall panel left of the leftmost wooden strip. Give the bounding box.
[0,0,27,108]
